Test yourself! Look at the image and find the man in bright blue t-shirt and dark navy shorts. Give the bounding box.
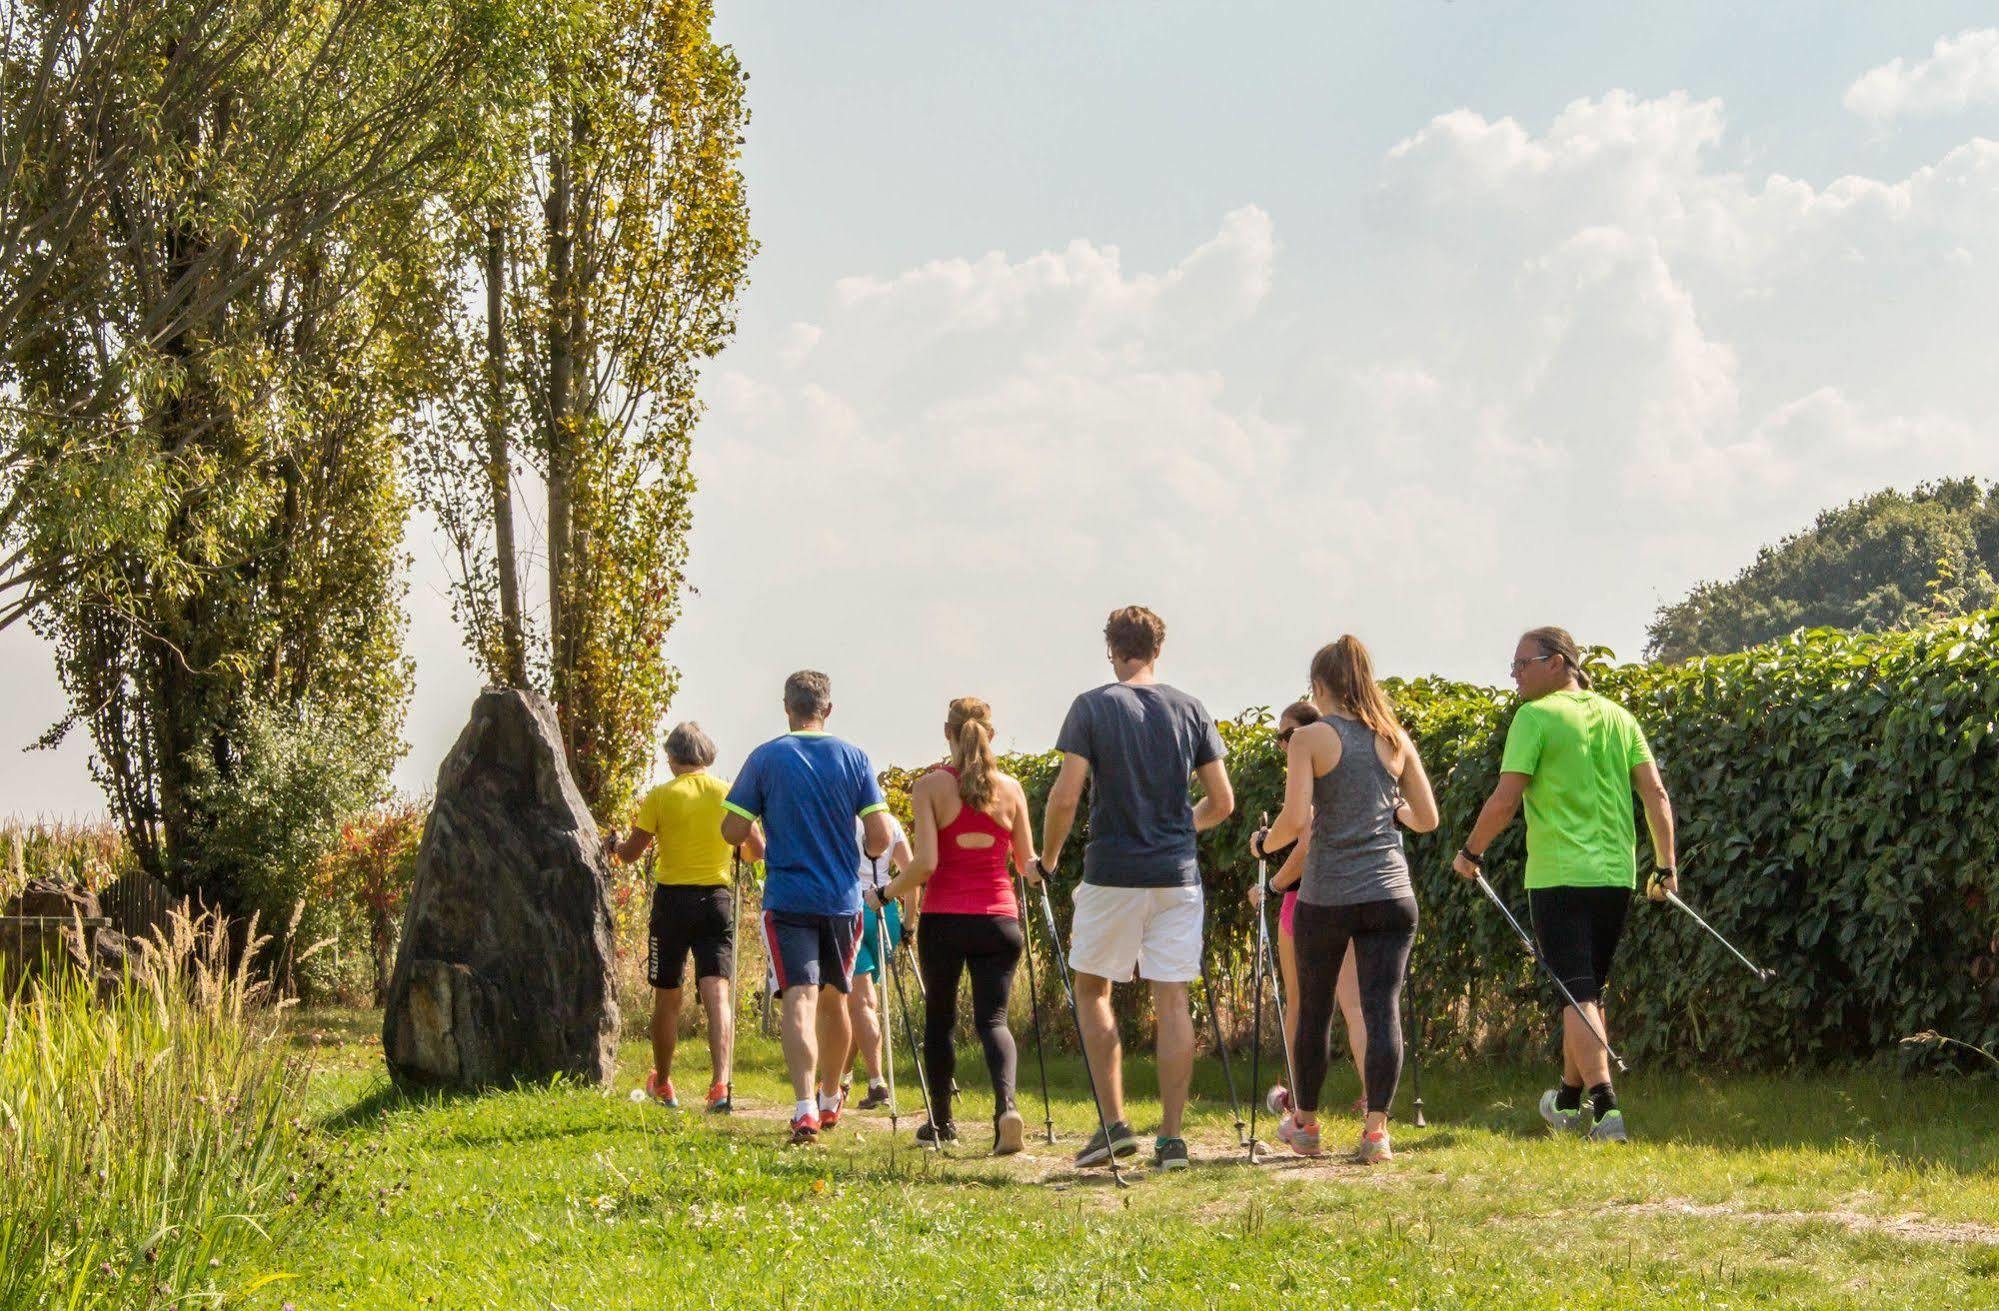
[722,669,890,1143]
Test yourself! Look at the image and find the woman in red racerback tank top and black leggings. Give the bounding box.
[868,697,1039,1155]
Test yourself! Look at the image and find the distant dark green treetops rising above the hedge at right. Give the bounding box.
[1649,478,1999,659]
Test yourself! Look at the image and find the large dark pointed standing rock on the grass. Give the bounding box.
[382,689,618,1087]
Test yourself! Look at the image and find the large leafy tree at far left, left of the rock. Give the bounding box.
[0,0,506,911]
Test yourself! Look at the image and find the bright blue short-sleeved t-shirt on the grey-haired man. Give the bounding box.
[722,733,888,915]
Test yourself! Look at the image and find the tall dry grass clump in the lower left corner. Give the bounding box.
[0,915,326,1311]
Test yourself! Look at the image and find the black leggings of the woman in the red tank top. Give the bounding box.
[916,915,1021,1123]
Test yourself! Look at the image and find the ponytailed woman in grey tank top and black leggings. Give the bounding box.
[1249,636,1437,1163]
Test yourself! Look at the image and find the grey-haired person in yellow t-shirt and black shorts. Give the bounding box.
[606,721,764,1115]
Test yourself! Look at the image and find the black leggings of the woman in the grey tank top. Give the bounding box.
[1291,897,1415,1113]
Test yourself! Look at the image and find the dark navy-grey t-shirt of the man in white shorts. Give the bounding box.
[1055,683,1225,887]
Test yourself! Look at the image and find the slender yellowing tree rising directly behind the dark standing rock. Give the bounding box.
[420,0,756,815]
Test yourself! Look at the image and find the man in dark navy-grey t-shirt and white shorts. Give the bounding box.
[1041,606,1235,1169]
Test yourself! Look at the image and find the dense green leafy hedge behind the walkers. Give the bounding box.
[888,612,1999,1067]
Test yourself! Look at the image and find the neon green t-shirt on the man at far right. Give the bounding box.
[1499,691,1651,887]
